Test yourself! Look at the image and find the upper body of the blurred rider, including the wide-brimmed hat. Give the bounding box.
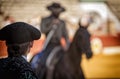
[41,3,69,52]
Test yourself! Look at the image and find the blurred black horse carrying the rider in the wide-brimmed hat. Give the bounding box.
[31,27,92,79]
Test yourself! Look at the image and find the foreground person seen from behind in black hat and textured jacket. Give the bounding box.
[0,22,41,79]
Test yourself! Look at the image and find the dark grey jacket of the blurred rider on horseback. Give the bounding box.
[40,15,69,43]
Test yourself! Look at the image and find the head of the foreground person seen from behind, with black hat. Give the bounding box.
[0,22,41,56]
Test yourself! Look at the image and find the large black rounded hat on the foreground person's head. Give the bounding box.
[0,22,41,44]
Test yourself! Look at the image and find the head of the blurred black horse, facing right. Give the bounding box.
[74,30,93,59]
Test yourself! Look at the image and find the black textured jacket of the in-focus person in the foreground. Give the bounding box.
[0,56,37,79]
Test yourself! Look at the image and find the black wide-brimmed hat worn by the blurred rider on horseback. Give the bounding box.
[47,2,65,12]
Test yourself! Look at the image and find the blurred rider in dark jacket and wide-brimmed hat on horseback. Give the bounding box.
[32,2,69,79]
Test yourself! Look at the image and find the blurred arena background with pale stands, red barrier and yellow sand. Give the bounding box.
[0,0,120,79]
